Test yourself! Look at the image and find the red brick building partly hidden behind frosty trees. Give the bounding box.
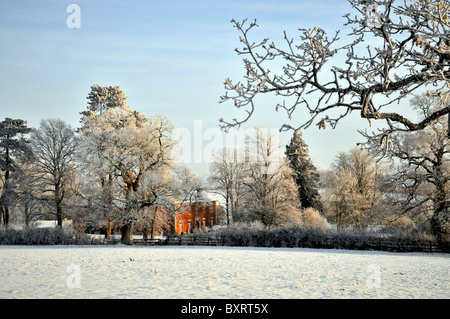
[174,201,217,234]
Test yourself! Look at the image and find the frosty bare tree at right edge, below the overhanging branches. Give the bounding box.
[388,95,450,240]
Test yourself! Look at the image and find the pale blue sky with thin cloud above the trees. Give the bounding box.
[0,0,394,175]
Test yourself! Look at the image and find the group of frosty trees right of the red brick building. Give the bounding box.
[210,94,450,242]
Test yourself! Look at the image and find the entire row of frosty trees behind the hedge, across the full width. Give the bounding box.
[0,85,450,244]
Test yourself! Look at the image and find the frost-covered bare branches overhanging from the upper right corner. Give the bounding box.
[220,0,450,142]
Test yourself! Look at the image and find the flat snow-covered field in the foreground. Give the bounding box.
[0,245,450,299]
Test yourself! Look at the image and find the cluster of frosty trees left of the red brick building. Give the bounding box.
[0,85,200,244]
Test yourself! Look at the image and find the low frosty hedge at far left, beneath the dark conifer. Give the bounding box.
[0,228,90,245]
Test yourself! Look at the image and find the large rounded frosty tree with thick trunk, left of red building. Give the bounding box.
[86,106,174,244]
